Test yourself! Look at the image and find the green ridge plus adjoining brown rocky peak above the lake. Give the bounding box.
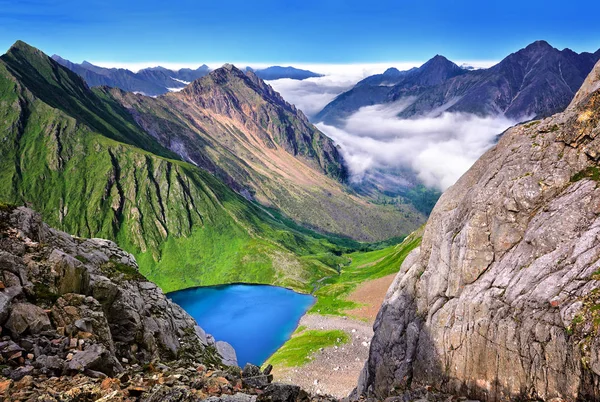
[0,42,424,291]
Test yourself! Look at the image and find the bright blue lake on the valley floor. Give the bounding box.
[168,284,315,367]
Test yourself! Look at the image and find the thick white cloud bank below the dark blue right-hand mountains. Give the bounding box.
[317,103,517,190]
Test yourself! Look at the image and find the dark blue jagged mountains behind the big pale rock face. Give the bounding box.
[315,41,600,125]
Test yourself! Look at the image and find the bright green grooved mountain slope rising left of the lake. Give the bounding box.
[0,42,376,291]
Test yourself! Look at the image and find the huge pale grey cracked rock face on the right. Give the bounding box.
[357,63,600,401]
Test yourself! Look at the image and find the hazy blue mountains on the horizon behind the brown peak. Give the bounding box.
[52,55,321,96]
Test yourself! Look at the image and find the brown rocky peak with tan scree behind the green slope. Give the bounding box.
[109,65,425,241]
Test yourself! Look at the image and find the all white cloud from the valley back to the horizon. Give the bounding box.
[262,62,510,190]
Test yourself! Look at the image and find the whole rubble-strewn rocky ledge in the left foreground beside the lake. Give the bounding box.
[0,209,326,401]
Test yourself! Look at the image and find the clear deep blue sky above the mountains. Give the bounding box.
[0,0,600,63]
